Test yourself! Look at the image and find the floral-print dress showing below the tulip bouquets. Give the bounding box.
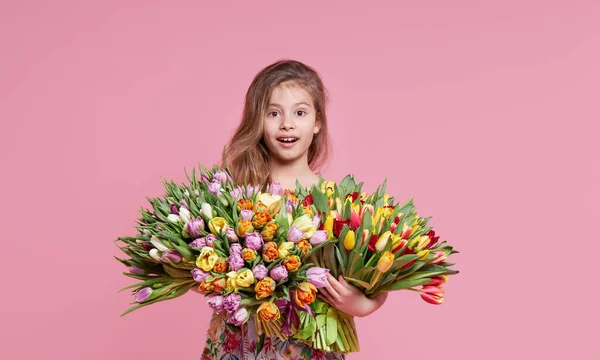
[201,314,345,360]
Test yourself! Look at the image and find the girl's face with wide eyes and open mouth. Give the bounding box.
[263,83,319,163]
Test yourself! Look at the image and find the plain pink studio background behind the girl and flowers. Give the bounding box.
[0,1,600,360]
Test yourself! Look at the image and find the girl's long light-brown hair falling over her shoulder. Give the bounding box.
[221,60,331,186]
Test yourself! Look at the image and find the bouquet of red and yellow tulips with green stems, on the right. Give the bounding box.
[297,175,458,352]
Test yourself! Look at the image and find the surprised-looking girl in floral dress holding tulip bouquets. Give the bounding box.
[202,60,387,360]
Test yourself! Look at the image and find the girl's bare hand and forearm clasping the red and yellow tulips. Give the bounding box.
[318,273,387,317]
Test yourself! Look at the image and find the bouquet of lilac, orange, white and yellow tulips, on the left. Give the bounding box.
[117,167,336,339]
